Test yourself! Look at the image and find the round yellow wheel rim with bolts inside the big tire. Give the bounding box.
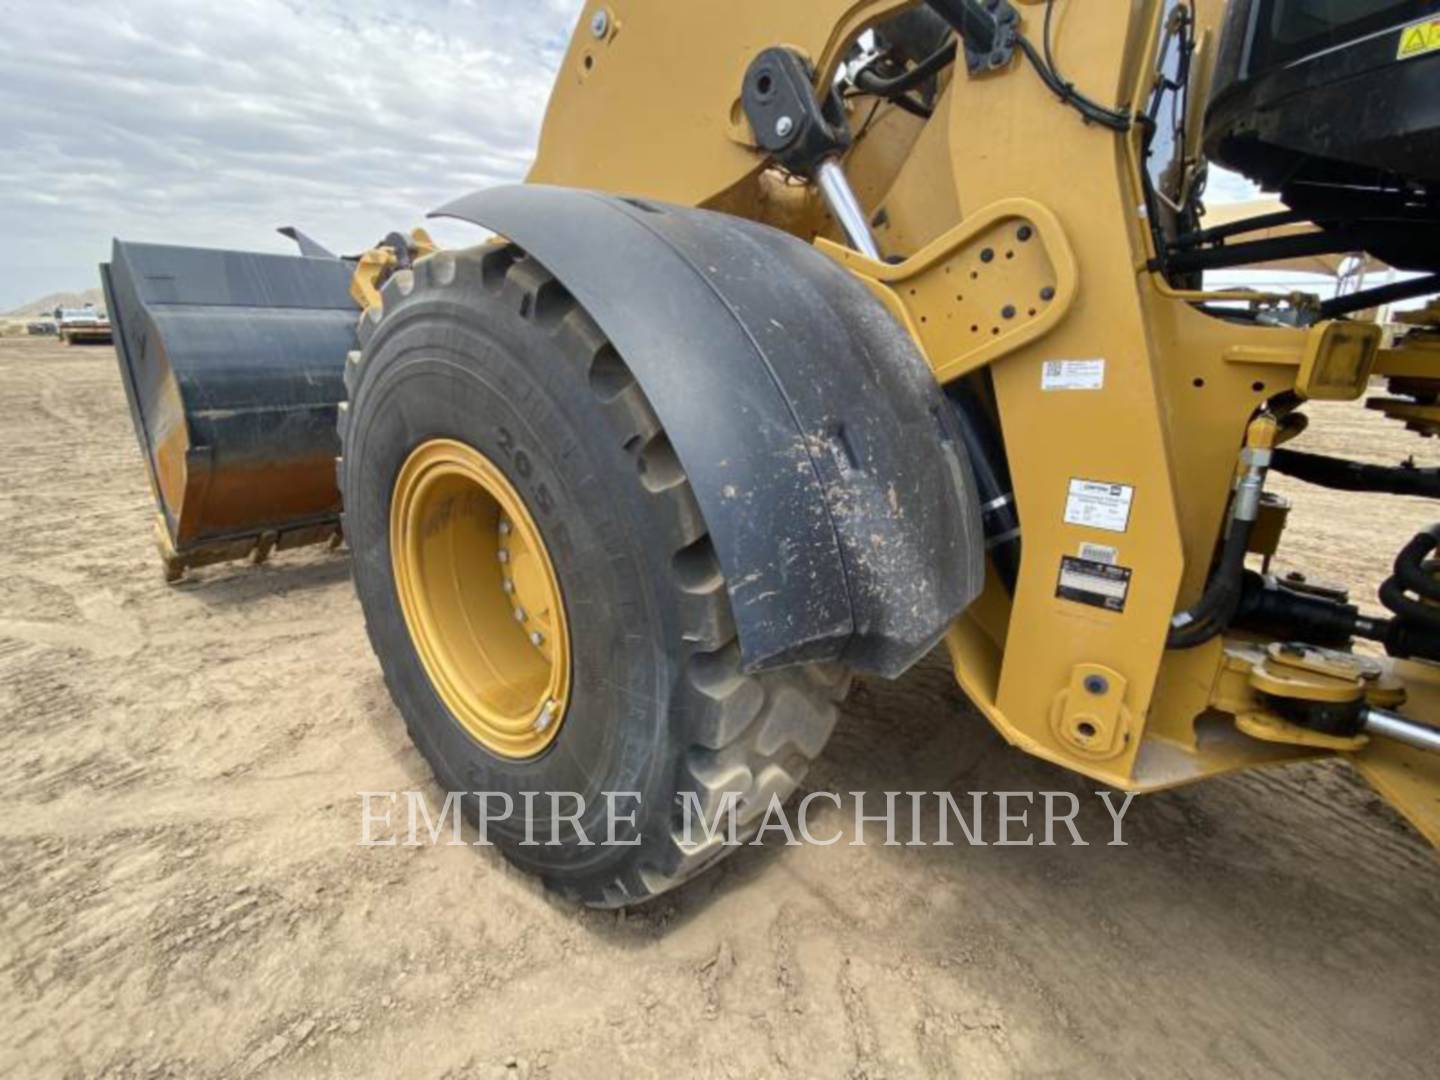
[390,439,570,759]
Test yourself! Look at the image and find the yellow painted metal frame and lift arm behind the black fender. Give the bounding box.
[528,0,1440,842]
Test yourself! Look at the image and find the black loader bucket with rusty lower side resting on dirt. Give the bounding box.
[101,240,359,580]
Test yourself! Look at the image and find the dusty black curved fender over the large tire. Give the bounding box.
[432,184,984,677]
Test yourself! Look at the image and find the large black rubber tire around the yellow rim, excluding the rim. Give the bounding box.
[338,245,850,907]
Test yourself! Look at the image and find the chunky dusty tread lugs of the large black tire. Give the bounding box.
[337,243,850,907]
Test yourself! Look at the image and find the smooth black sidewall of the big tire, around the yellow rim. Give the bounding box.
[343,289,684,877]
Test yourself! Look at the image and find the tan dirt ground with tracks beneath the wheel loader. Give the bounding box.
[0,340,1440,1080]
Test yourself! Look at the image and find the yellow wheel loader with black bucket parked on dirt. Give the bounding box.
[102,0,1440,906]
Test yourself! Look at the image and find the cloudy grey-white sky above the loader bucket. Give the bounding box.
[0,0,1272,311]
